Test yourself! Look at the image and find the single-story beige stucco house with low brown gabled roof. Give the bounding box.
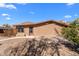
[14,20,68,37]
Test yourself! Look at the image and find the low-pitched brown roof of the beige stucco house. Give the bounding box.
[14,20,69,27]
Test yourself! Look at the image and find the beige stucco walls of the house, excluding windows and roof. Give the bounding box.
[17,23,62,37]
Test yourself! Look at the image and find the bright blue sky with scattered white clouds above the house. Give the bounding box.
[0,3,79,24]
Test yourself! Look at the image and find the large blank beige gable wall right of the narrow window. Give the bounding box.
[33,24,62,37]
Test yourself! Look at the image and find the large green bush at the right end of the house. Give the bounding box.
[62,20,79,45]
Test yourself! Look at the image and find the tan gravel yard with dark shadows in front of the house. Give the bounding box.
[0,37,79,56]
